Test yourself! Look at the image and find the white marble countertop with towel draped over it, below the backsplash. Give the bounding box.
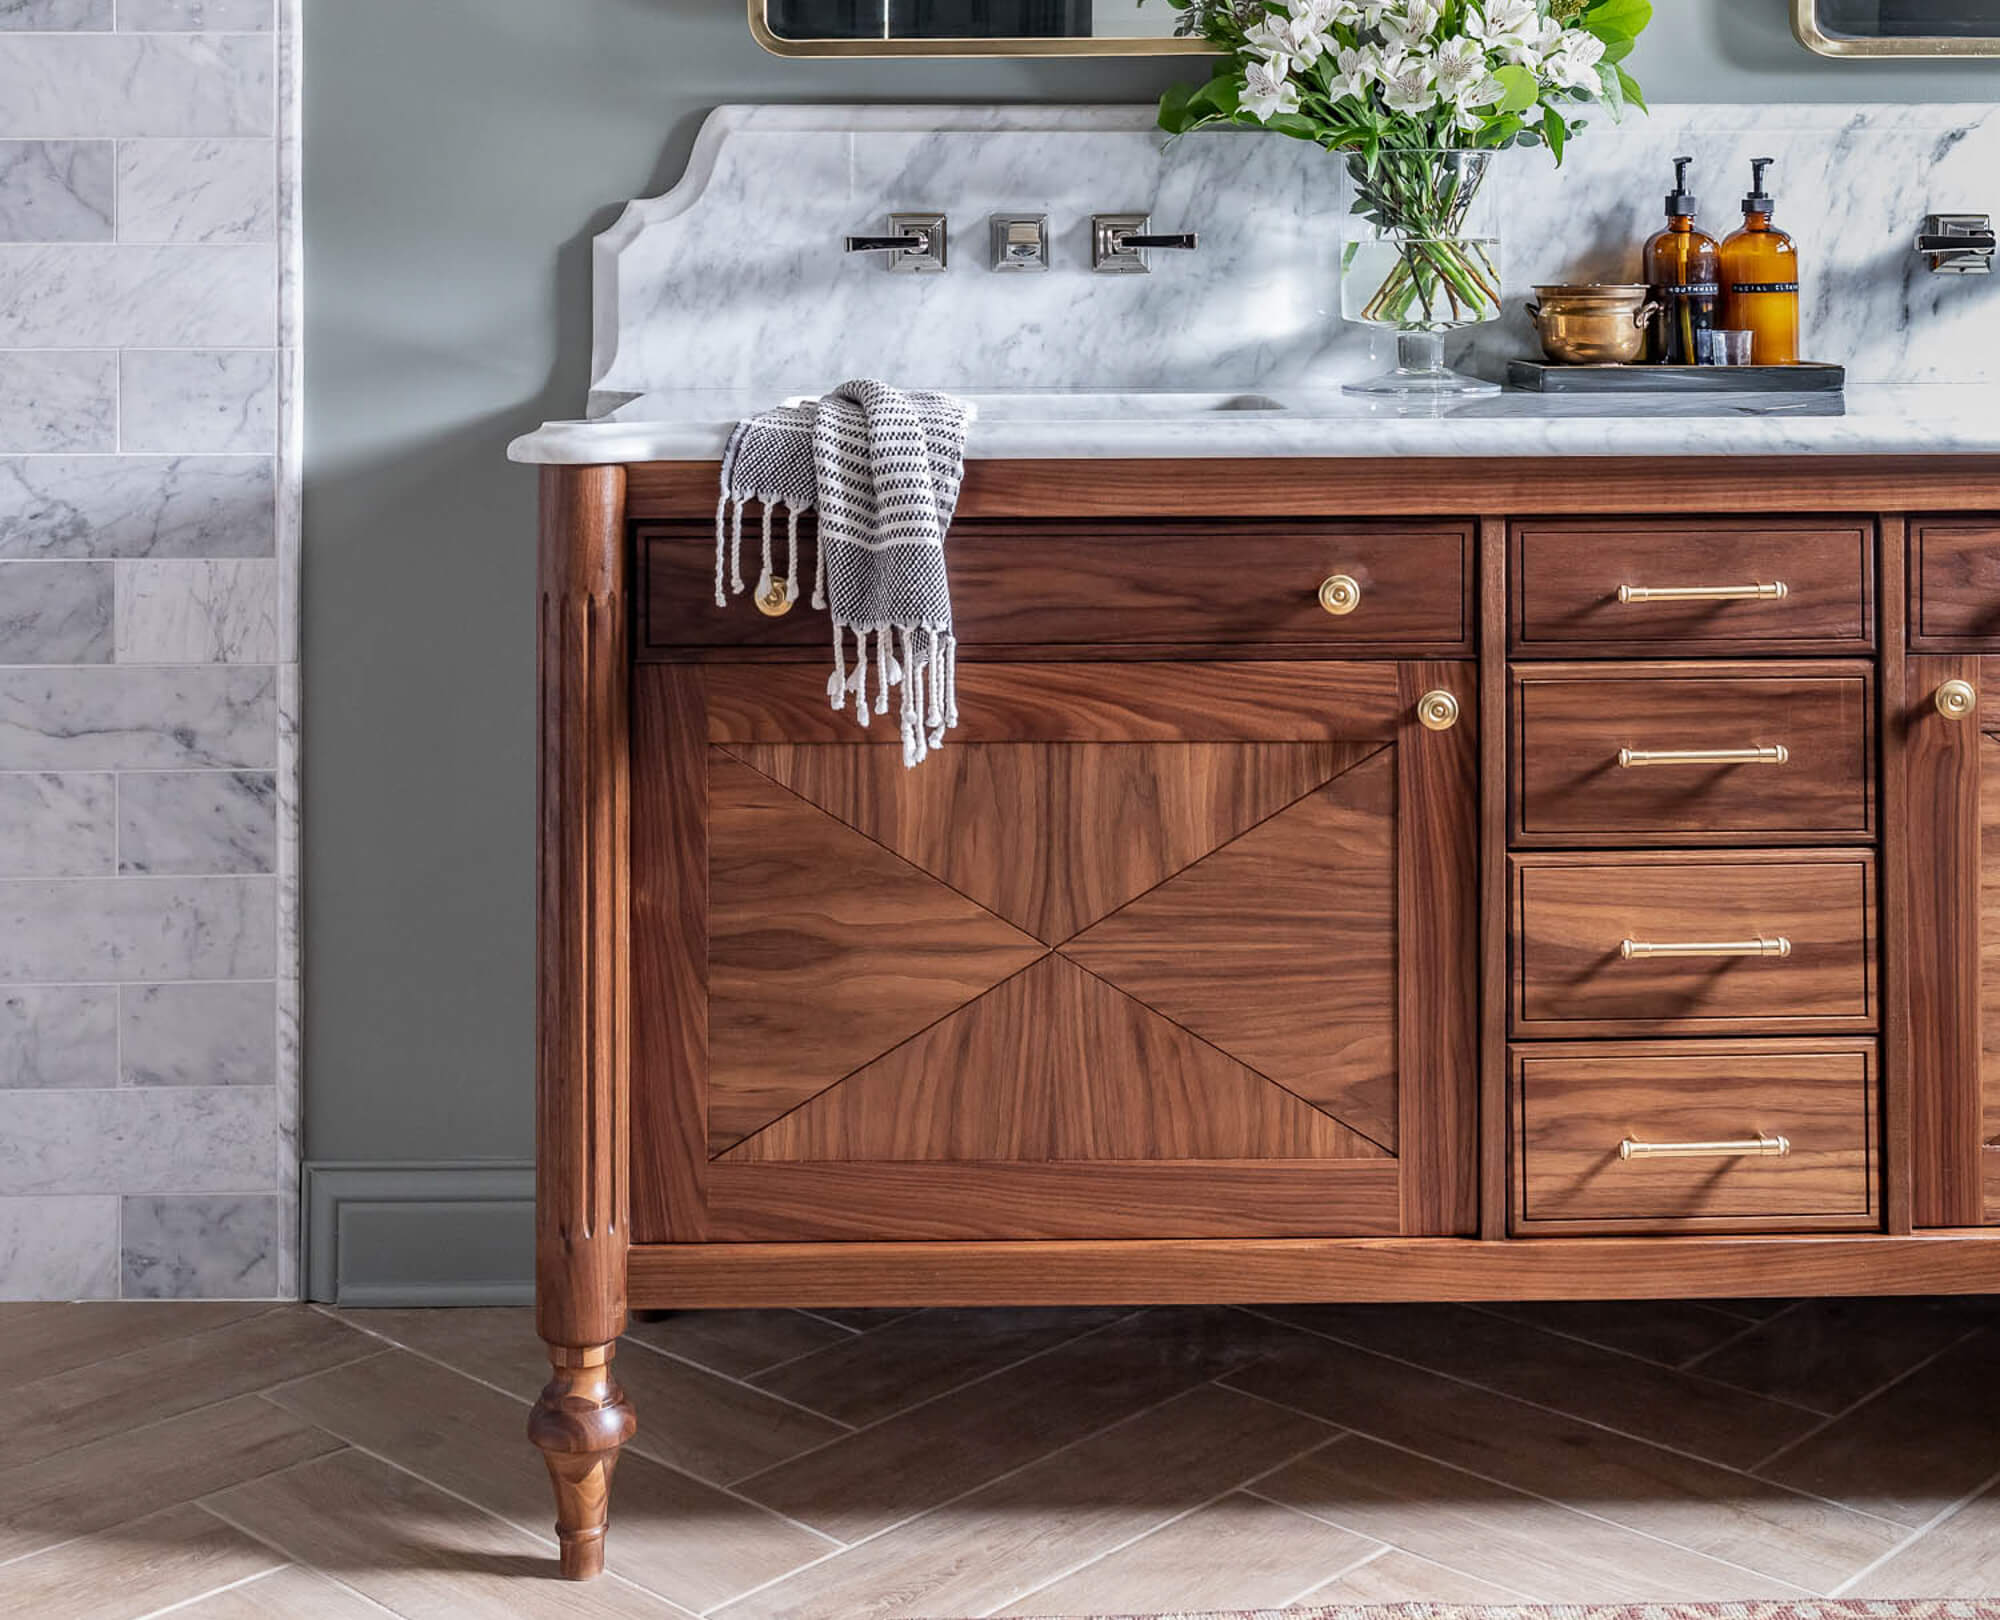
[508,382,2000,466]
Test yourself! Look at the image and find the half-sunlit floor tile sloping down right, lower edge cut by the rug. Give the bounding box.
[1256,1436,1800,1602]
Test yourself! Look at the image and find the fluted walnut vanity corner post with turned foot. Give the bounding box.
[528,468,634,1580]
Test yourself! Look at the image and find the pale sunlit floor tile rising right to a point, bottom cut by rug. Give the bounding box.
[998,1494,1382,1614]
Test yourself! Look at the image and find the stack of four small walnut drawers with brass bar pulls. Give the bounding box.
[1508,518,1880,1234]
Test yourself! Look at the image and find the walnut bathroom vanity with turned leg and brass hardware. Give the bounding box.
[532,454,2000,1576]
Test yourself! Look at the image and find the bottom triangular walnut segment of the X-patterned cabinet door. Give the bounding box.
[724,956,1384,1164]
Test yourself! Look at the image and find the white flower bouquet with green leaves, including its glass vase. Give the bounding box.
[1160,0,1652,394]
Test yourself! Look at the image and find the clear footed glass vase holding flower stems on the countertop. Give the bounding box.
[1340,150,1500,398]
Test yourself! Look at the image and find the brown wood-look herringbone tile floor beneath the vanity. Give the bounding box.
[0,1300,2000,1620]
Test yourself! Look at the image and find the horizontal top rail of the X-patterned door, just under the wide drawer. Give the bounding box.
[706,660,1402,748]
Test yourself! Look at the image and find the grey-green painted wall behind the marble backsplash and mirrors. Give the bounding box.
[304,0,2000,1162]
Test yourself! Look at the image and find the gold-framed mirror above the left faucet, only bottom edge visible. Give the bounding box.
[750,0,1210,56]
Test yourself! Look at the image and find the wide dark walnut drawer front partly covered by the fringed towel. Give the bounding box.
[638,512,1472,658]
